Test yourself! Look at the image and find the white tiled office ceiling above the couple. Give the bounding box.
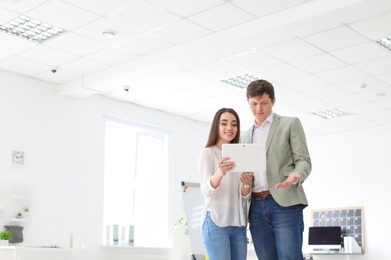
[0,0,391,138]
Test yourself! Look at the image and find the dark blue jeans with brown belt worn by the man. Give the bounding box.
[249,196,304,260]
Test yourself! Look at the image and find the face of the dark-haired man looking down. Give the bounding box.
[248,94,276,125]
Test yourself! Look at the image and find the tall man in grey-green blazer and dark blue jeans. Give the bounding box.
[241,80,311,260]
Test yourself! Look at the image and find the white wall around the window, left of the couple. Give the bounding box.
[0,72,209,260]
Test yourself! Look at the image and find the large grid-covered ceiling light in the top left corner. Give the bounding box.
[0,15,64,43]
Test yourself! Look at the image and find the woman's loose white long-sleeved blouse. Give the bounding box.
[199,146,251,227]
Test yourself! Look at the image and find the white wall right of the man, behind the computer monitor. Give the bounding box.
[304,126,391,260]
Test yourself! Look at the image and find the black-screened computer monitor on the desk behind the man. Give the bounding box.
[308,227,342,250]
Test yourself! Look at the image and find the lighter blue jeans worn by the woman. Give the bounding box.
[202,212,247,260]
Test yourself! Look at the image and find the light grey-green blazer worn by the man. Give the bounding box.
[240,114,311,207]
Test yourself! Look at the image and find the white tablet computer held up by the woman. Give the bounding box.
[222,144,266,172]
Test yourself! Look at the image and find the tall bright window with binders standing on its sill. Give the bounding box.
[103,118,172,247]
